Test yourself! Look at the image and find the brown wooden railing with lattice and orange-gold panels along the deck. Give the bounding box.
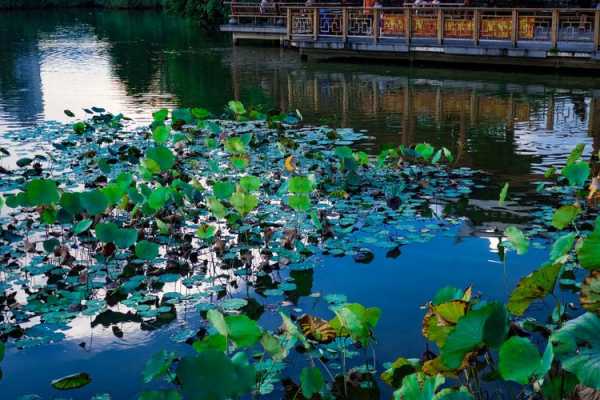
[225,2,600,51]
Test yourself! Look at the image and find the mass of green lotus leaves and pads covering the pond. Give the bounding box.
[0,102,600,399]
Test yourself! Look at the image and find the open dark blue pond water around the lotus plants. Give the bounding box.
[0,11,600,399]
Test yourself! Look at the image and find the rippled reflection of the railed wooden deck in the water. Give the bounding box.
[231,48,600,176]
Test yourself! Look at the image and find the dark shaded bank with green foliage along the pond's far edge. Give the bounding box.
[0,0,226,29]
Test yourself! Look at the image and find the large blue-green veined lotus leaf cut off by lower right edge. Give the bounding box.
[550,312,600,390]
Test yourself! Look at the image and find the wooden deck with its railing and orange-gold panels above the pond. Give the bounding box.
[221,3,600,70]
